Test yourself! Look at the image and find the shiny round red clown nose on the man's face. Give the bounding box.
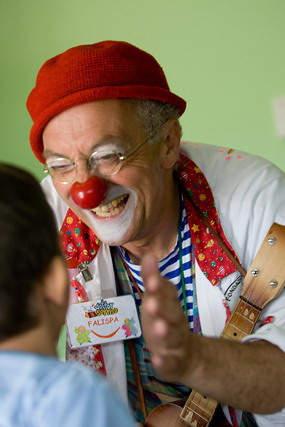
[70,176,107,209]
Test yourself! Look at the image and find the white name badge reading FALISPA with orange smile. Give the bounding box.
[66,295,141,348]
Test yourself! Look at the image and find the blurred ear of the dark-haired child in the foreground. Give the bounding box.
[43,255,69,306]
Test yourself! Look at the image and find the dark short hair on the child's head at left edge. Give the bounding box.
[0,164,61,341]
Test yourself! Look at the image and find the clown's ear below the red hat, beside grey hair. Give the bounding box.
[160,119,181,169]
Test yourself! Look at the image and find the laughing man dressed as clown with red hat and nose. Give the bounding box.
[27,41,285,426]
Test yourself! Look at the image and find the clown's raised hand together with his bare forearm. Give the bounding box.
[141,255,285,414]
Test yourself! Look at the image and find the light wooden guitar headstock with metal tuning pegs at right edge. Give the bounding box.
[242,223,285,309]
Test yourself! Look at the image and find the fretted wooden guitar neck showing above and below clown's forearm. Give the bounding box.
[180,297,261,427]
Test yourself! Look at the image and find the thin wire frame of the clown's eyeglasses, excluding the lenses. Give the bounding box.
[43,119,165,184]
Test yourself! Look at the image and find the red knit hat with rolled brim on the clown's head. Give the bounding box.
[27,41,186,163]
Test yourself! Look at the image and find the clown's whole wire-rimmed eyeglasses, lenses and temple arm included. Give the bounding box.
[44,123,164,184]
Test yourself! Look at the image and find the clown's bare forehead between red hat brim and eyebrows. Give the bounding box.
[43,99,145,158]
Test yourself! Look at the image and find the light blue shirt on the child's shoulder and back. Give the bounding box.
[0,351,134,427]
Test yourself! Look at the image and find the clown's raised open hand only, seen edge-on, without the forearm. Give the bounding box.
[141,255,195,382]
